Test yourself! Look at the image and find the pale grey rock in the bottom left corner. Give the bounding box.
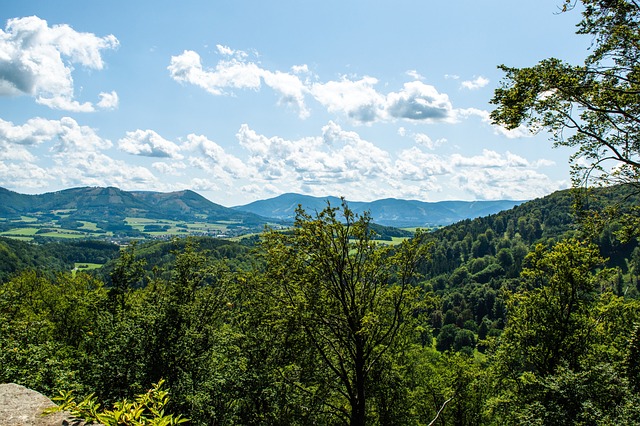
[0,383,84,426]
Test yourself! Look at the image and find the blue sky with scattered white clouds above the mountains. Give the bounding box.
[0,0,590,207]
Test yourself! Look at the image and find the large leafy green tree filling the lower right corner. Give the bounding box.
[493,240,639,425]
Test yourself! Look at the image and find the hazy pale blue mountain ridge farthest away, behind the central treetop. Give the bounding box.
[233,194,524,227]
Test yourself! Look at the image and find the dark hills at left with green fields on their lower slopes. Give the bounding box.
[0,187,273,239]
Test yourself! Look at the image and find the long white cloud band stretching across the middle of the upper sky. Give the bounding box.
[168,46,472,124]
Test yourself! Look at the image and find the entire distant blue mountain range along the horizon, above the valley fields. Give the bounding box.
[0,187,522,227]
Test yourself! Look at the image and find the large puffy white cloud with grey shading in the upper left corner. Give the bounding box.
[0,16,118,112]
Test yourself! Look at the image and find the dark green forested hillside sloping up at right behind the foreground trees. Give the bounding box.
[428,186,640,282]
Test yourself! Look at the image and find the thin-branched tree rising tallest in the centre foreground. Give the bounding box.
[263,202,427,425]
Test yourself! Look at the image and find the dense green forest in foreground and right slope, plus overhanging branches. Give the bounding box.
[0,0,640,426]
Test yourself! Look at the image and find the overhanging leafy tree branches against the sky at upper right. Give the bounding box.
[491,0,640,190]
